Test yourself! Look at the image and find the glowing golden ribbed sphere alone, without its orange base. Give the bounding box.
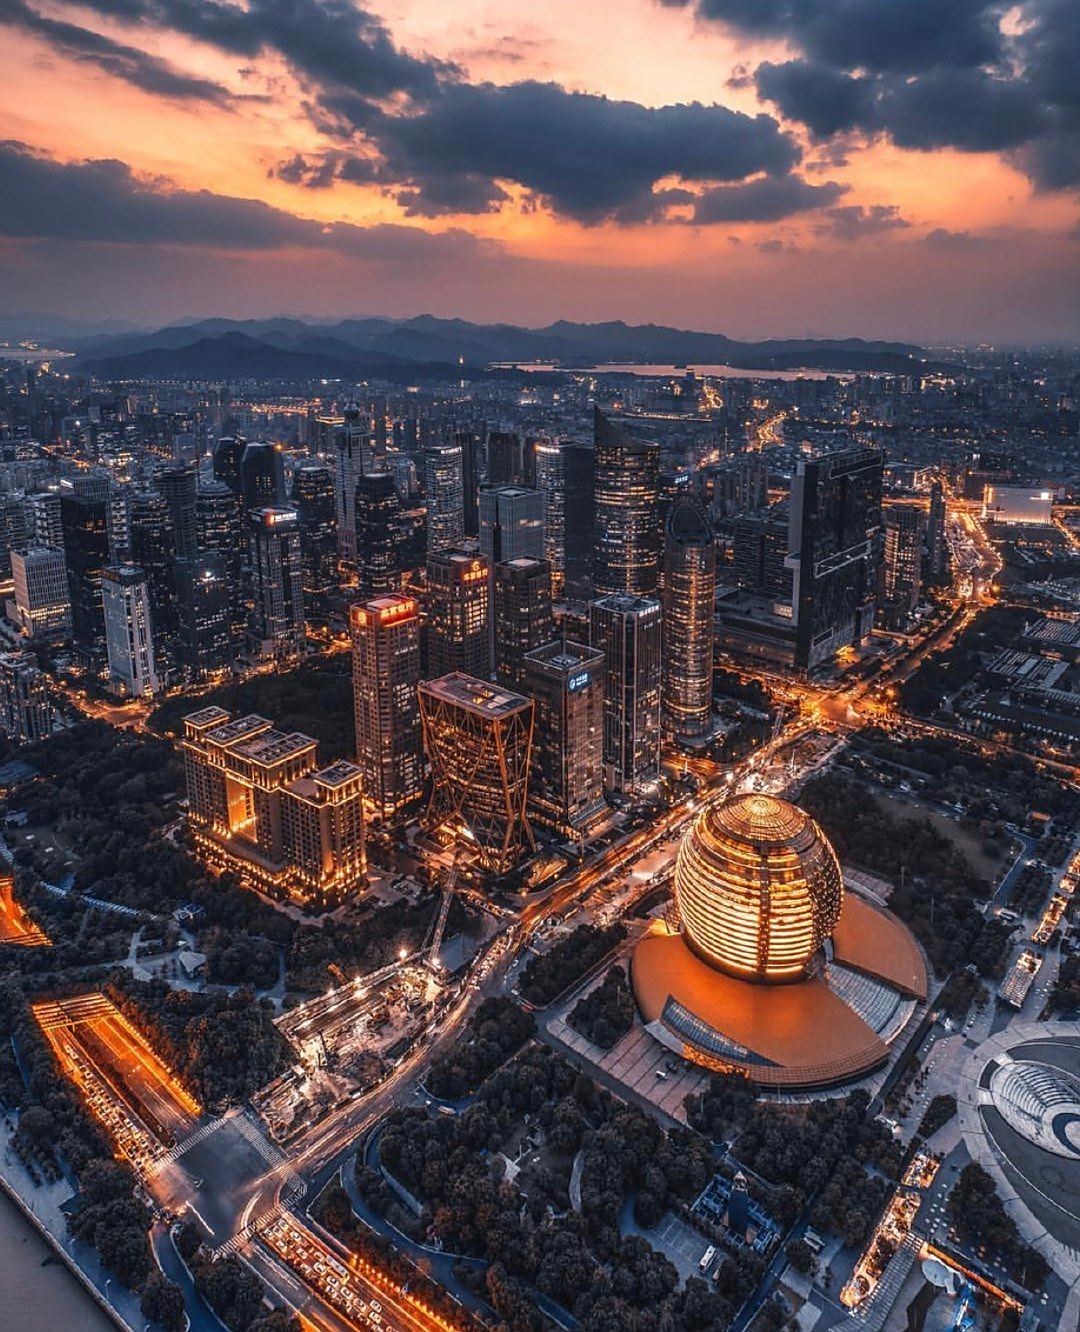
[675,794,843,983]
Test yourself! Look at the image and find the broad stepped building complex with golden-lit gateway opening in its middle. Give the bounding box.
[181,707,366,907]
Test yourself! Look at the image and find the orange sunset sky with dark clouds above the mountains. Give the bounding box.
[0,0,1080,342]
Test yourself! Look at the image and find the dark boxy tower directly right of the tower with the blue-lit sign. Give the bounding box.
[589,594,661,795]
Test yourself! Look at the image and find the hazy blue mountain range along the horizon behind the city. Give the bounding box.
[71,314,930,378]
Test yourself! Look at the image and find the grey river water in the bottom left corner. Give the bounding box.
[0,1192,116,1332]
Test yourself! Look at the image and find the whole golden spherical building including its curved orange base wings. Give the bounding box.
[633,794,927,1088]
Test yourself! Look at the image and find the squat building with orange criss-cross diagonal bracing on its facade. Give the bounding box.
[419,671,535,874]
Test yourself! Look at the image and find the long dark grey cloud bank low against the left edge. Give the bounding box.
[0,141,483,262]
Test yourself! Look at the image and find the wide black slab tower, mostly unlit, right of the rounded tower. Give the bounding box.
[787,448,882,670]
